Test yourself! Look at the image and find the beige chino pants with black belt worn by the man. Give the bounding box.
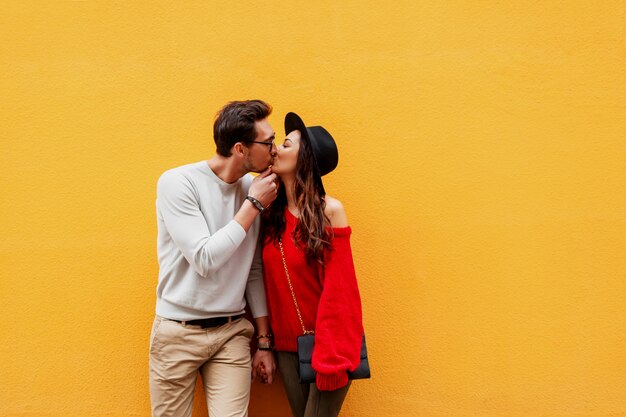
[149,316,254,417]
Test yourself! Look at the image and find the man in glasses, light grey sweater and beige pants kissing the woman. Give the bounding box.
[150,100,277,417]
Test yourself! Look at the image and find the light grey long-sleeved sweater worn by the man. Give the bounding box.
[156,161,267,320]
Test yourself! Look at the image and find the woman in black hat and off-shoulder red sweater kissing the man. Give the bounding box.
[263,113,363,417]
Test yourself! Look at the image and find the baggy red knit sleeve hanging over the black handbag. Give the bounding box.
[312,227,363,391]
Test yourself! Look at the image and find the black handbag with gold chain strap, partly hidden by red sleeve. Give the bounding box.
[278,240,371,384]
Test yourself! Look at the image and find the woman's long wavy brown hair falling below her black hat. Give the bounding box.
[261,132,332,265]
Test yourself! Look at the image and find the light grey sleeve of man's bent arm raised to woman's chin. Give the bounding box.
[157,171,246,277]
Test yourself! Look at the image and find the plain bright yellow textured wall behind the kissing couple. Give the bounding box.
[0,1,626,417]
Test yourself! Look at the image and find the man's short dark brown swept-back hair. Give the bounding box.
[213,100,272,156]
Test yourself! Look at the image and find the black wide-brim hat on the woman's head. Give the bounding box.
[285,112,339,195]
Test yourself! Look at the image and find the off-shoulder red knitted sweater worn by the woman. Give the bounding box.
[263,209,363,390]
